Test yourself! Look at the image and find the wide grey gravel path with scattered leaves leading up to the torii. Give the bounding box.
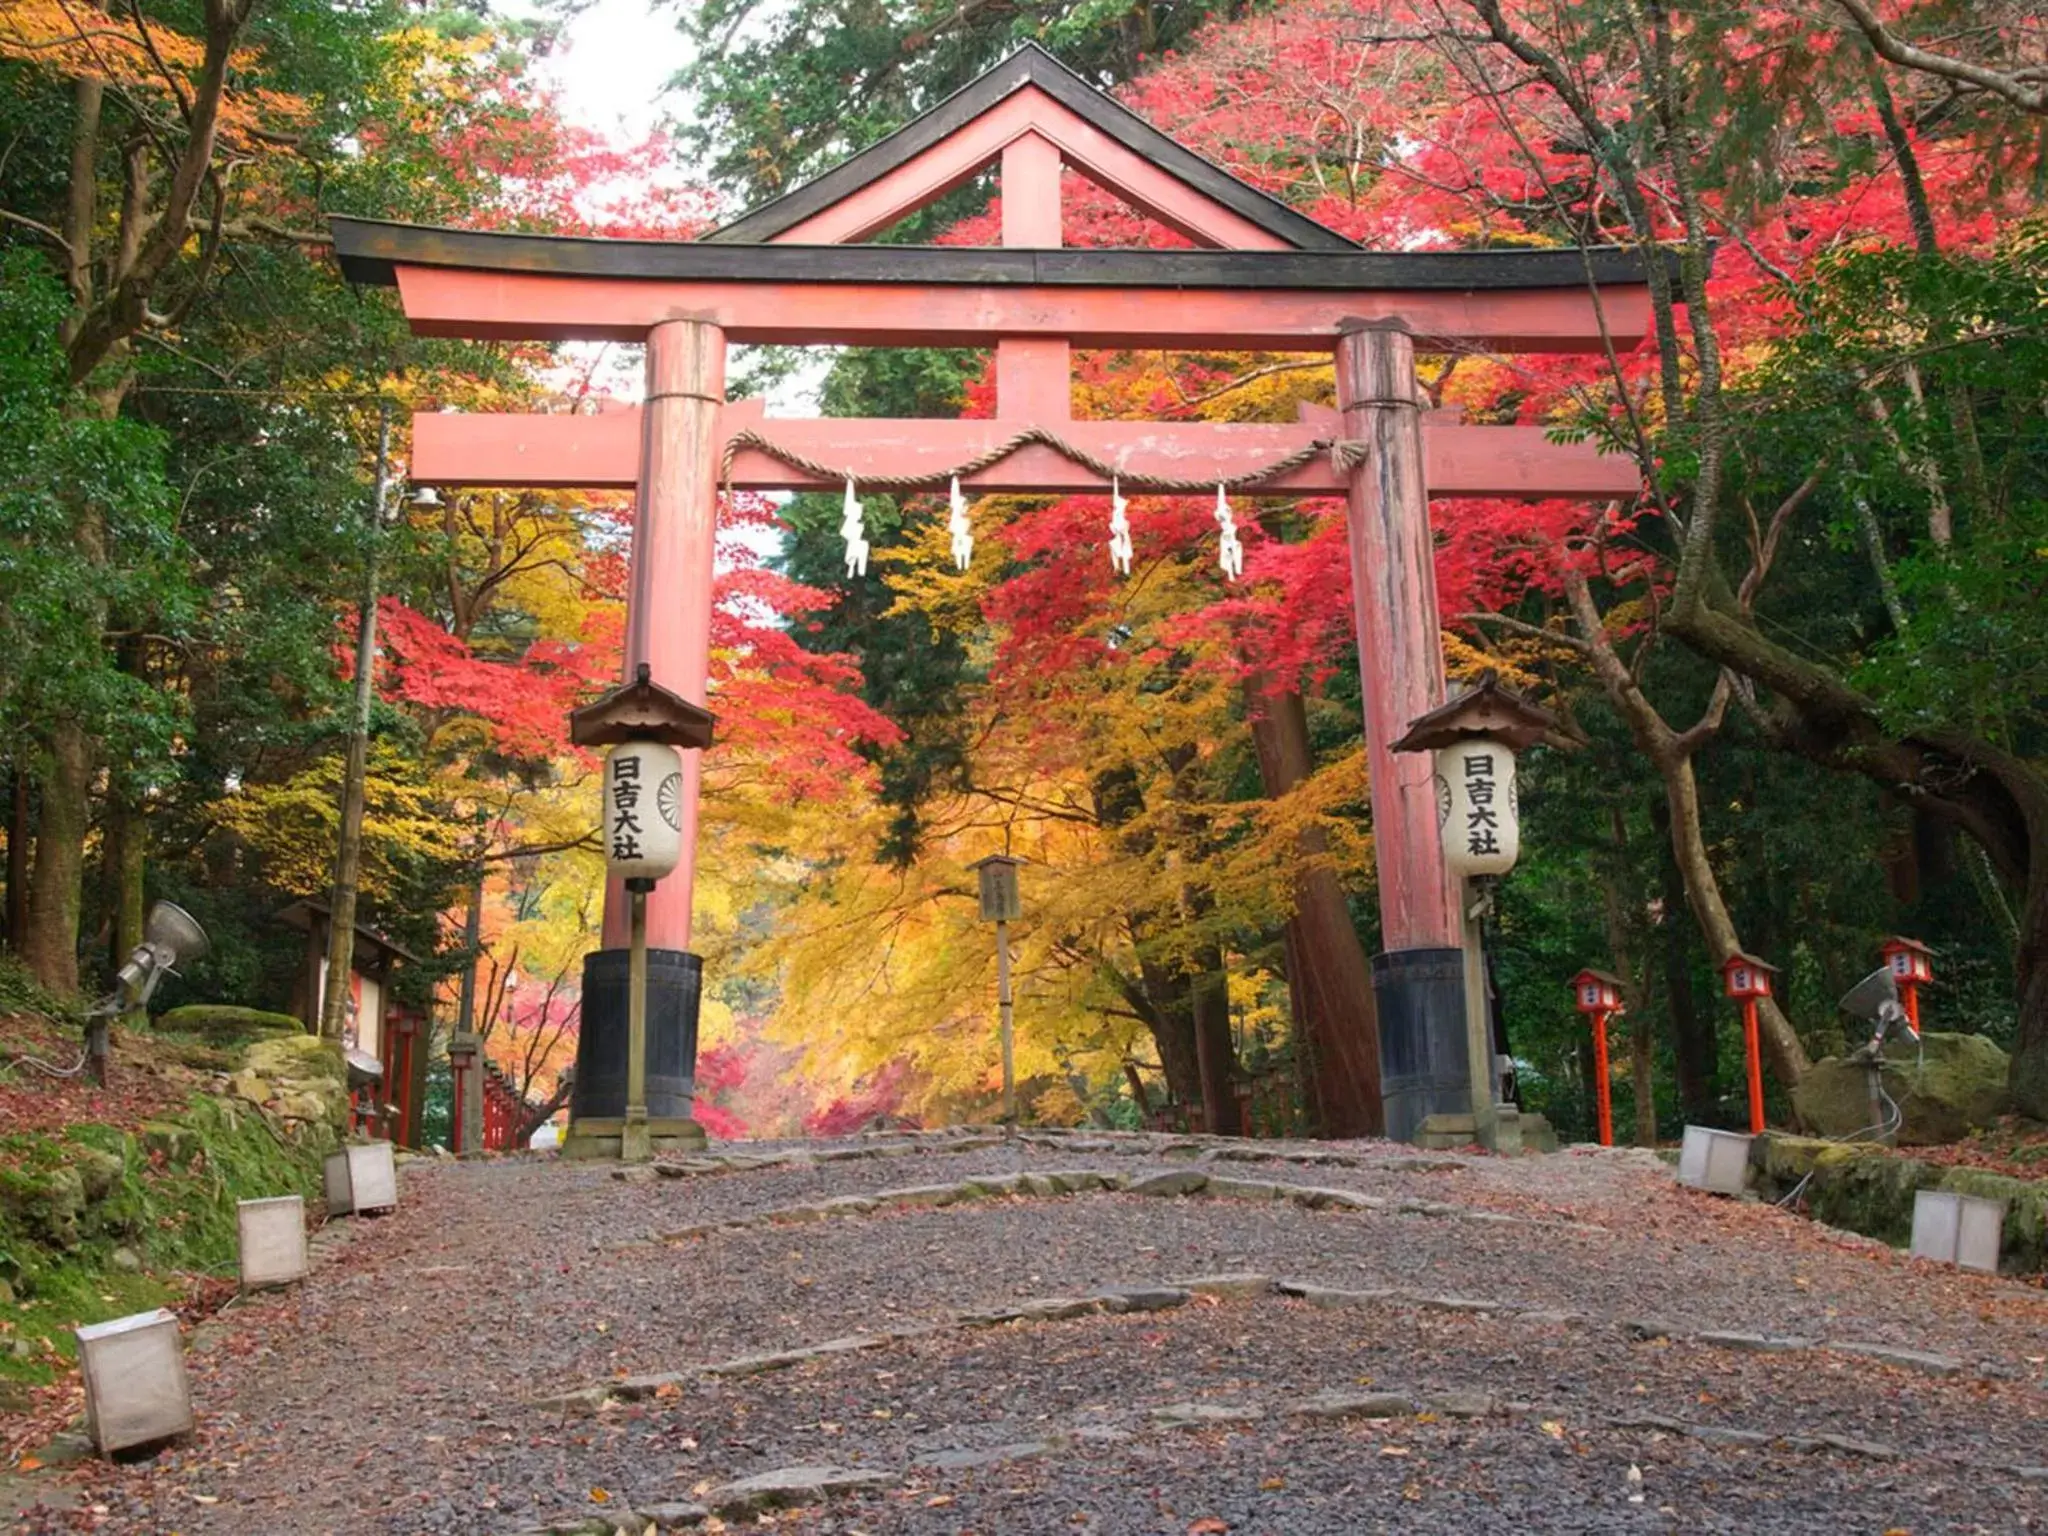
[8,1139,2048,1536]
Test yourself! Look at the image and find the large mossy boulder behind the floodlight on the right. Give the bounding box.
[1792,1034,2011,1147]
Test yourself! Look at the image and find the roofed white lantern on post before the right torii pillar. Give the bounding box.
[1382,672,1556,1147]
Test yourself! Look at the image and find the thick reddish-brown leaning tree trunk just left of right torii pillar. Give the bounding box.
[1249,690,1386,1137]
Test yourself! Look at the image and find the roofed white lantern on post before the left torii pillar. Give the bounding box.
[569,662,713,1163]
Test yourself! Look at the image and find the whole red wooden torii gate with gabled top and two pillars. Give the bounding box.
[330,45,1649,1146]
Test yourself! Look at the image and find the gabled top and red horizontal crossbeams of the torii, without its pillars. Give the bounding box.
[330,45,1669,496]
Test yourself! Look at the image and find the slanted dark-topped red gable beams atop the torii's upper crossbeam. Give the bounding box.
[702,43,1358,250]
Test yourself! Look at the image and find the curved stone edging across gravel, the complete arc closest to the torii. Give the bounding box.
[638,1167,1610,1247]
